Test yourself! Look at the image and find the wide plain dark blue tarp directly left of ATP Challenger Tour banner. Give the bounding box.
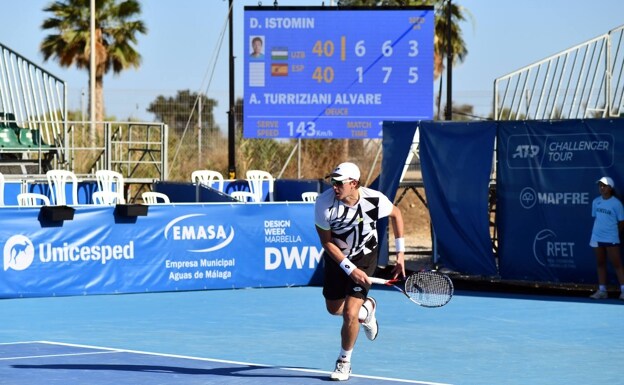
[419,122,497,275]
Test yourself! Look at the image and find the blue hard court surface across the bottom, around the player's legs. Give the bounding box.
[0,287,624,385]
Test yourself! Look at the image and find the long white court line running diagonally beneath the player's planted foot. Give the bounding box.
[0,341,452,385]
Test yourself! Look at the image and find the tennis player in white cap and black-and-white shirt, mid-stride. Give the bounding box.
[314,162,405,381]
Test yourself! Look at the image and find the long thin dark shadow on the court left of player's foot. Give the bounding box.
[11,364,329,381]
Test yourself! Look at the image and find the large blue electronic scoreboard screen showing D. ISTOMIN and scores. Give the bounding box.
[243,7,434,139]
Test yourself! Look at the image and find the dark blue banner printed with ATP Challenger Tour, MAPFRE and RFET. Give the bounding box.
[497,119,624,283]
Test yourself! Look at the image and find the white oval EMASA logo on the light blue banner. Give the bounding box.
[165,214,234,253]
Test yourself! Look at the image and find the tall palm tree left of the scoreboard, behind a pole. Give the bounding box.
[40,0,147,121]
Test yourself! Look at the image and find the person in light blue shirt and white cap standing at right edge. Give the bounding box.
[589,176,624,300]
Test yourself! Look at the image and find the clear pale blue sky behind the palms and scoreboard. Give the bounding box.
[0,0,624,130]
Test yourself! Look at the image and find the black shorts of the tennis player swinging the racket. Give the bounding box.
[323,247,379,300]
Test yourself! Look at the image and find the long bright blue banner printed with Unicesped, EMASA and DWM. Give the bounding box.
[0,203,322,297]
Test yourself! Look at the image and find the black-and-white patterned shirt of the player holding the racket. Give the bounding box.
[314,187,394,258]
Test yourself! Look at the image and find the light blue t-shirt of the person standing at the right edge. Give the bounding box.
[590,196,624,247]
